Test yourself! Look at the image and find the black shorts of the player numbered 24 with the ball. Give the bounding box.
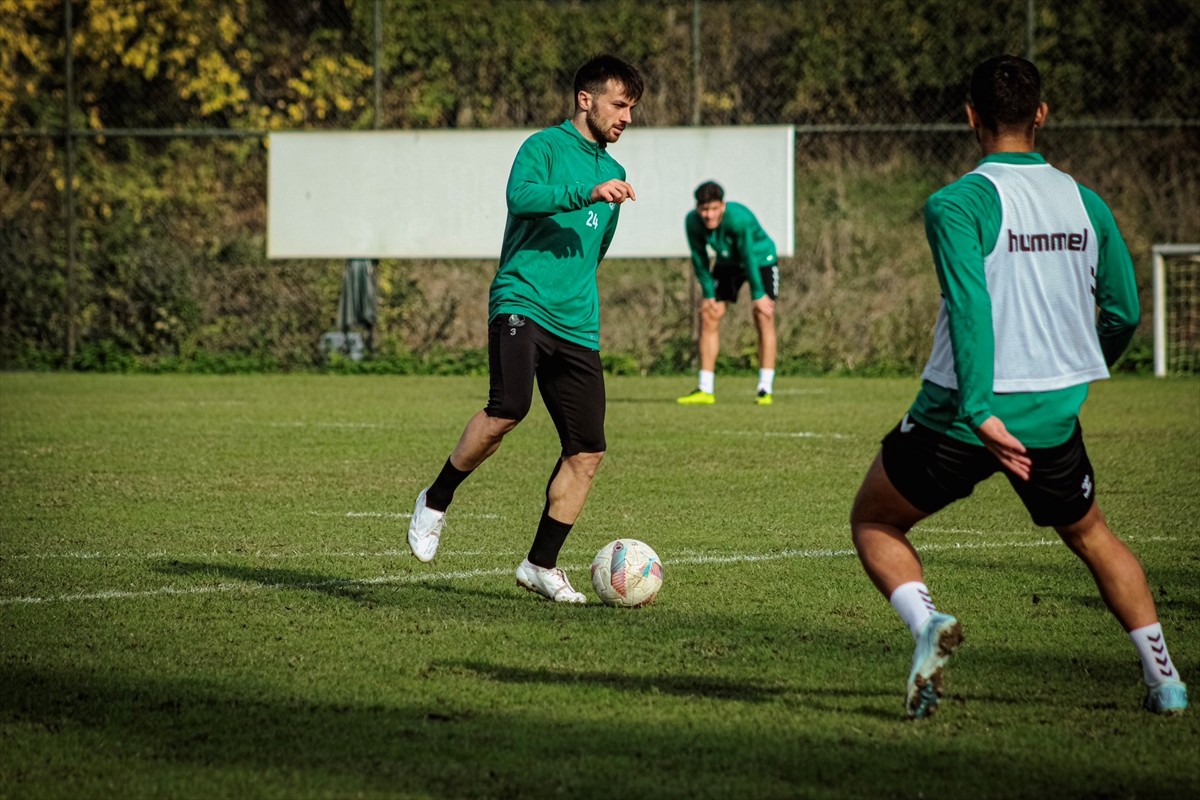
[484,314,606,456]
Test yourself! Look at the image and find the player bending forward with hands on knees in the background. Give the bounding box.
[678,181,779,405]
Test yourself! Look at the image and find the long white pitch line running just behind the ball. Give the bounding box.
[0,536,1175,606]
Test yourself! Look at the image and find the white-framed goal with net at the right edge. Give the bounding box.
[1151,245,1200,377]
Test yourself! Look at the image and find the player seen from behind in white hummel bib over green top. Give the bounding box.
[851,55,1188,717]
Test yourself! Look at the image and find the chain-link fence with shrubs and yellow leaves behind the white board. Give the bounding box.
[0,0,1200,372]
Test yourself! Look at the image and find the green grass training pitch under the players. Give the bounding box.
[0,374,1200,799]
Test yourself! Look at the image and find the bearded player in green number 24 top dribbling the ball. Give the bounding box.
[408,55,642,603]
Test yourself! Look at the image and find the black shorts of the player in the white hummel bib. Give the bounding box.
[883,414,1096,525]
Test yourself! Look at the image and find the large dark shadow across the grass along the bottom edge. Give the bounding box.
[0,662,1200,800]
